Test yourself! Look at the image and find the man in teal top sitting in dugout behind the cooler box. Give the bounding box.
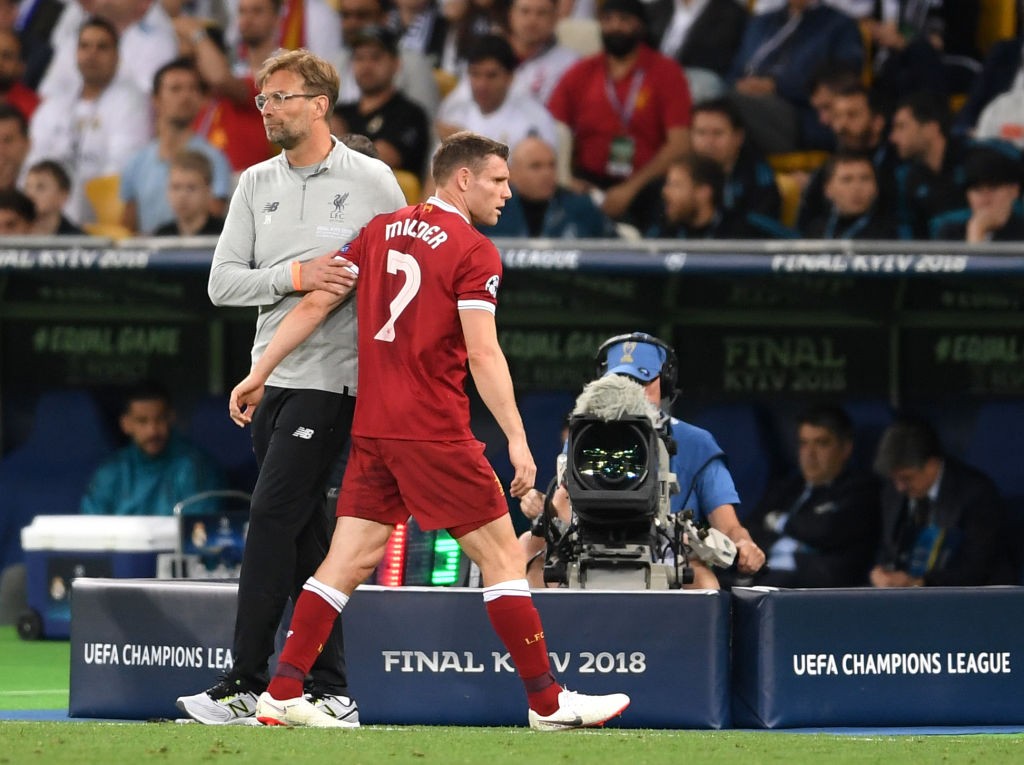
[81,382,227,515]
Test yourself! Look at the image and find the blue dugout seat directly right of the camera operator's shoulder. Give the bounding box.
[690,403,778,517]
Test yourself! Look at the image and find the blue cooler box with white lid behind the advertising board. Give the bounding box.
[18,515,178,640]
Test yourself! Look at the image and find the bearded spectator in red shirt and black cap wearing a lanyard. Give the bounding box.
[548,0,690,230]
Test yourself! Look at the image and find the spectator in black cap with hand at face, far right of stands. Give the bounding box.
[932,146,1024,243]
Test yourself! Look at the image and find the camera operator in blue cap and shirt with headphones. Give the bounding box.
[520,332,765,589]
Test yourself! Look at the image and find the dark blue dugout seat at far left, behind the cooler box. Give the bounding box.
[0,390,116,566]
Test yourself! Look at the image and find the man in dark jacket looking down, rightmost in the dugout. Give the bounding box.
[870,419,1013,587]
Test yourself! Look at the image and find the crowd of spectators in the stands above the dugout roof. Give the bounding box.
[0,0,1024,242]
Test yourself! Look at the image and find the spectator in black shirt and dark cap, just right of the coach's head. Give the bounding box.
[332,27,430,179]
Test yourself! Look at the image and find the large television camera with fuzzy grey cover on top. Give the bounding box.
[542,375,736,590]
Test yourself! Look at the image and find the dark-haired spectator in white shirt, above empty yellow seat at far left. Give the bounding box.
[26,16,150,223]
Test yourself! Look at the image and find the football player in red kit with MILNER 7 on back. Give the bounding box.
[230,132,630,730]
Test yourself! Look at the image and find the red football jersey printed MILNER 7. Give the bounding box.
[342,197,502,440]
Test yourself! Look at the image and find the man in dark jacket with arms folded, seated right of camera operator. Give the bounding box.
[746,405,879,587]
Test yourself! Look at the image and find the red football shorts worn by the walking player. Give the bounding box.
[338,435,508,539]
